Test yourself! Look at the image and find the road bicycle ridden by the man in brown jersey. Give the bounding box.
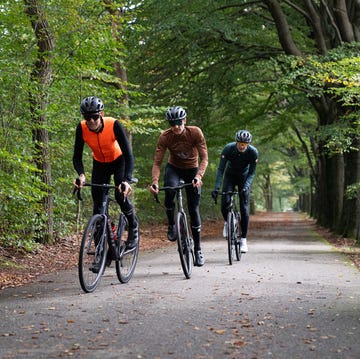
[154,181,194,279]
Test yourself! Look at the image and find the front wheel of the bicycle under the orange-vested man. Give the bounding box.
[78,214,107,293]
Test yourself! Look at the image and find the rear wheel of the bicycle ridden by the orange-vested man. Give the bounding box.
[115,213,140,283]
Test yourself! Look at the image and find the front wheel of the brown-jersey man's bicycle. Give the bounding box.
[176,212,194,279]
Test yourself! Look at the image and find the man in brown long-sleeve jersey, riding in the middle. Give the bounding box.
[150,106,208,267]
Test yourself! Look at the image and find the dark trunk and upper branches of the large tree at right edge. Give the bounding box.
[264,0,360,236]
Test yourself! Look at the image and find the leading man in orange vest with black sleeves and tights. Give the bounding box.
[73,96,139,249]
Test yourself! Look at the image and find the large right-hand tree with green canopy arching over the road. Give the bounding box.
[126,0,359,239]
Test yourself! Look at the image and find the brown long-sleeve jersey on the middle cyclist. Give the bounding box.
[152,126,208,184]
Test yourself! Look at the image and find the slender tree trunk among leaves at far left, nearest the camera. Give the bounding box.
[24,0,54,244]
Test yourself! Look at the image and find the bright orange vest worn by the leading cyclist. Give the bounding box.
[81,117,122,162]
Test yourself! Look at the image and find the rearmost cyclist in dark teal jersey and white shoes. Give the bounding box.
[211,130,258,253]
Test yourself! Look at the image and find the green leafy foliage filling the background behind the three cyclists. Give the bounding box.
[0,0,360,249]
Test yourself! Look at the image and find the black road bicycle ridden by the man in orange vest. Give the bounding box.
[74,179,140,293]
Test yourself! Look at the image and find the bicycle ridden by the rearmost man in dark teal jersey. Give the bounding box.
[215,191,241,265]
